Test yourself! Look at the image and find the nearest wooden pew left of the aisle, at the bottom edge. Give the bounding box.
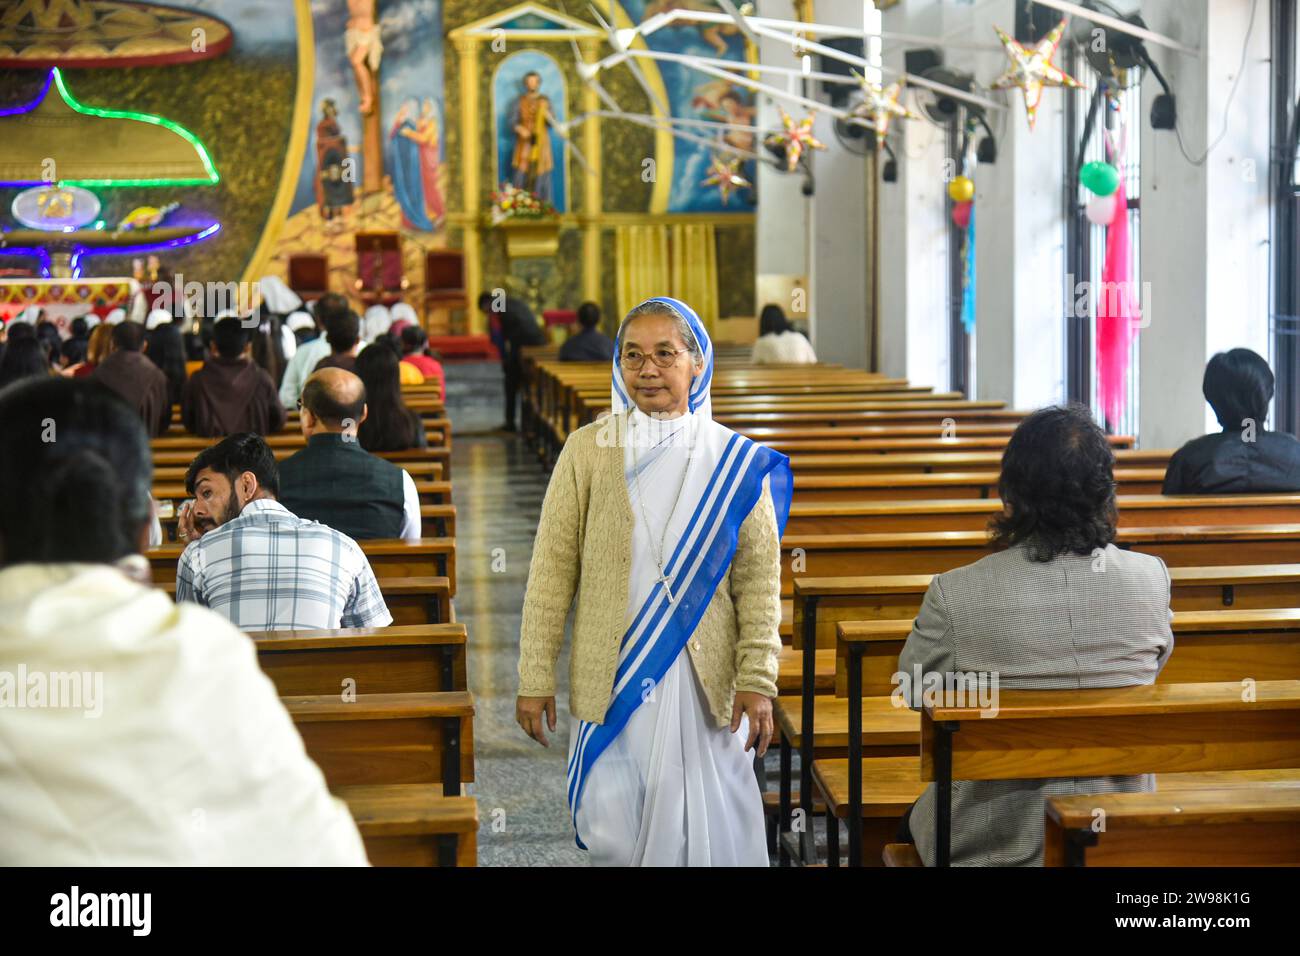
[335,783,478,866]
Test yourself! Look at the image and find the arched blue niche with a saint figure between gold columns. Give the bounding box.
[491,49,568,212]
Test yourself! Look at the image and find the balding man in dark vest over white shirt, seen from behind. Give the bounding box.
[280,368,420,541]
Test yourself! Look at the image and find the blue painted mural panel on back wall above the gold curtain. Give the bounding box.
[611,0,757,212]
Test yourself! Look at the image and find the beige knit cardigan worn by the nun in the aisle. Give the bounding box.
[519,412,781,727]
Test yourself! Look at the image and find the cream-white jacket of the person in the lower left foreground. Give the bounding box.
[0,564,367,866]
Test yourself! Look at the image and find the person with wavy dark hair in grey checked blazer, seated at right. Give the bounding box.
[898,405,1174,866]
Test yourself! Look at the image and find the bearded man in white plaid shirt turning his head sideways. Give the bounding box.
[176,432,393,631]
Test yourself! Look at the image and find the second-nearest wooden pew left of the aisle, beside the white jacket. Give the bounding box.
[281,691,475,796]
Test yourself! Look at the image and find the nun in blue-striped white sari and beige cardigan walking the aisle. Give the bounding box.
[516,298,792,866]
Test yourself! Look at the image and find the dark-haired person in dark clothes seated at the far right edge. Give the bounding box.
[1161,349,1300,494]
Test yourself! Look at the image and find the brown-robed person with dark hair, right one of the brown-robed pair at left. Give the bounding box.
[181,316,286,437]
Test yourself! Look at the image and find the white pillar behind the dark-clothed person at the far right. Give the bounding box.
[1139,0,1270,447]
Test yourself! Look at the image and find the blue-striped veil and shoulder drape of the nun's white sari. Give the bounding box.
[568,298,793,849]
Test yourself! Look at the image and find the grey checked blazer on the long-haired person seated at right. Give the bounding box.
[898,545,1174,866]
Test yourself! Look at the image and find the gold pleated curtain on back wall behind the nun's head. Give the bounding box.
[615,222,718,333]
